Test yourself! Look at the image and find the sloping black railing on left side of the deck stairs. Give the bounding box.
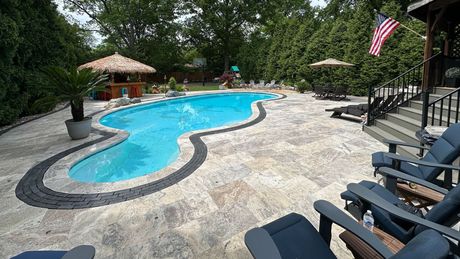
[367,54,441,126]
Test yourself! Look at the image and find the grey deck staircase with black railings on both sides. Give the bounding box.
[363,53,460,158]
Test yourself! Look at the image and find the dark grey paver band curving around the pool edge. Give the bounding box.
[16,94,286,209]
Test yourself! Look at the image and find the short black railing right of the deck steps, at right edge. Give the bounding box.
[422,87,460,128]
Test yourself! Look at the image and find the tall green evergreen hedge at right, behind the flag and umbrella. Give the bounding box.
[236,0,424,95]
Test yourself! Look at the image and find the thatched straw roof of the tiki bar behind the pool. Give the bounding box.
[78,52,156,74]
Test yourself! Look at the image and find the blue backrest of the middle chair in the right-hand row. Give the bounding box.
[415,185,460,234]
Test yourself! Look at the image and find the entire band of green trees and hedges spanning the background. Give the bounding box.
[0,0,424,125]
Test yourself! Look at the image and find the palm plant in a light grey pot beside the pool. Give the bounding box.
[44,67,108,139]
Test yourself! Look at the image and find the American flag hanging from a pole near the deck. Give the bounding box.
[369,13,399,56]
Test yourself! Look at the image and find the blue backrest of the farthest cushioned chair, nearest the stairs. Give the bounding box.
[420,123,460,181]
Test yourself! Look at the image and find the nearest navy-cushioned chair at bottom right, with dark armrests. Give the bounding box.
[245,200,452,259]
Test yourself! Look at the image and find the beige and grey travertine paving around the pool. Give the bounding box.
[0,93,386,258]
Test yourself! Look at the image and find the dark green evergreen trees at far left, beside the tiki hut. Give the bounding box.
[0,0,89,125]
